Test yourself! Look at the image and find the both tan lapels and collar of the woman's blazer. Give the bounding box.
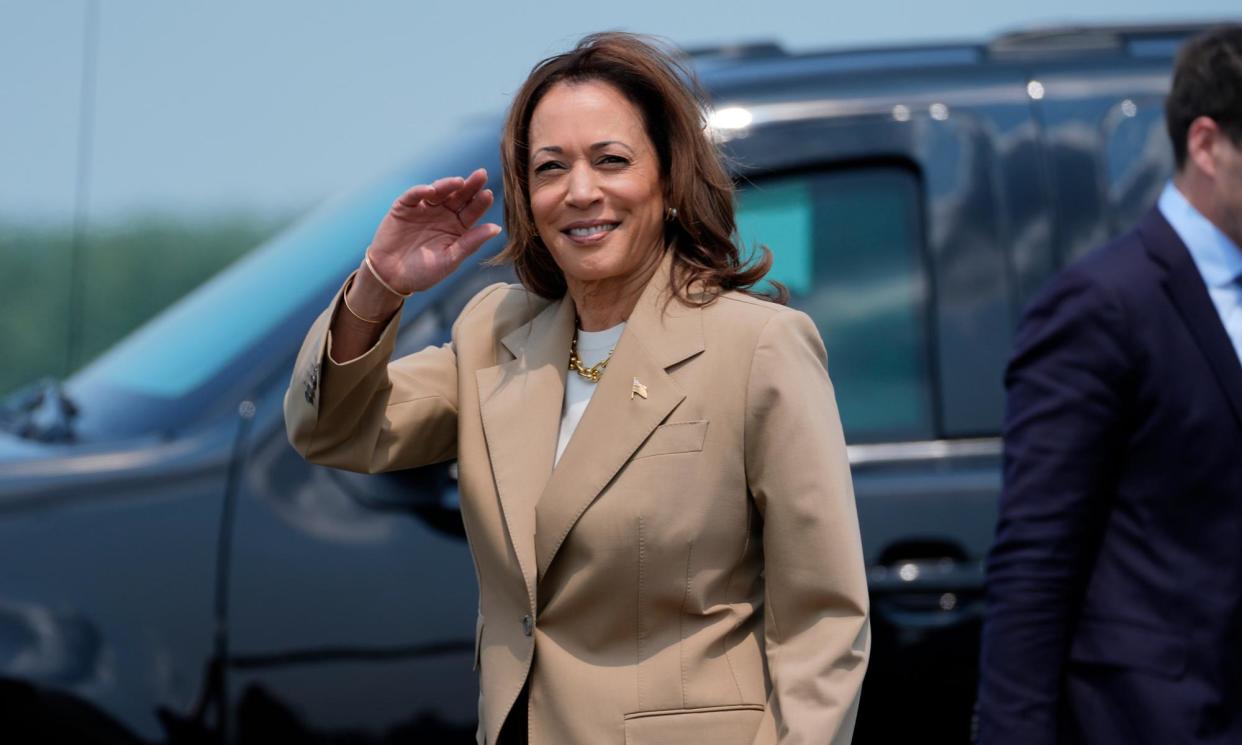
[476,253,703,605]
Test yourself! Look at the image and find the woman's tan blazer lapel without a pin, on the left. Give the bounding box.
[474,297,574,602]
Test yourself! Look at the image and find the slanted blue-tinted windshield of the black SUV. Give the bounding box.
[67,122,499,436]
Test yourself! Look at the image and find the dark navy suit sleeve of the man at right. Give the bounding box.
[979,269,1129,745]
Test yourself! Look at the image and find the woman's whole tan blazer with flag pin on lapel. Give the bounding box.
[284,253,869,745]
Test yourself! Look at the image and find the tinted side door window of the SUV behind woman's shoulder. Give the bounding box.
[738,166,934,442]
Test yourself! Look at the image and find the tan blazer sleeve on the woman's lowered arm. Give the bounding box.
[744,312,871,745]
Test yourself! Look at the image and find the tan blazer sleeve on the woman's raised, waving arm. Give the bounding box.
[284,274,502,473]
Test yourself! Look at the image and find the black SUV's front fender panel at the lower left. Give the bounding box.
[0,429,236,744]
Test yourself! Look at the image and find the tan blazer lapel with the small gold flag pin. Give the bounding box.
[535,258,703,577]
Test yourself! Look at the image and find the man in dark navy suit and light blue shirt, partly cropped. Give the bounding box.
[979,26,1242,745]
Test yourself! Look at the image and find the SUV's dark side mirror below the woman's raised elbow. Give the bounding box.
[329,461,466,539]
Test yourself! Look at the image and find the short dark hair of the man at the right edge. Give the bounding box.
[1165,25,1242,170]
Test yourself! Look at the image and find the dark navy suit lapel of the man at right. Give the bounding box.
[1139,210,1242,426]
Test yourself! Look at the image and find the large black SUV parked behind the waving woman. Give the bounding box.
[0,26,1201,743]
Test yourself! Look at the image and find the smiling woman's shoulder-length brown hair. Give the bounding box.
[493,32,789,304]
